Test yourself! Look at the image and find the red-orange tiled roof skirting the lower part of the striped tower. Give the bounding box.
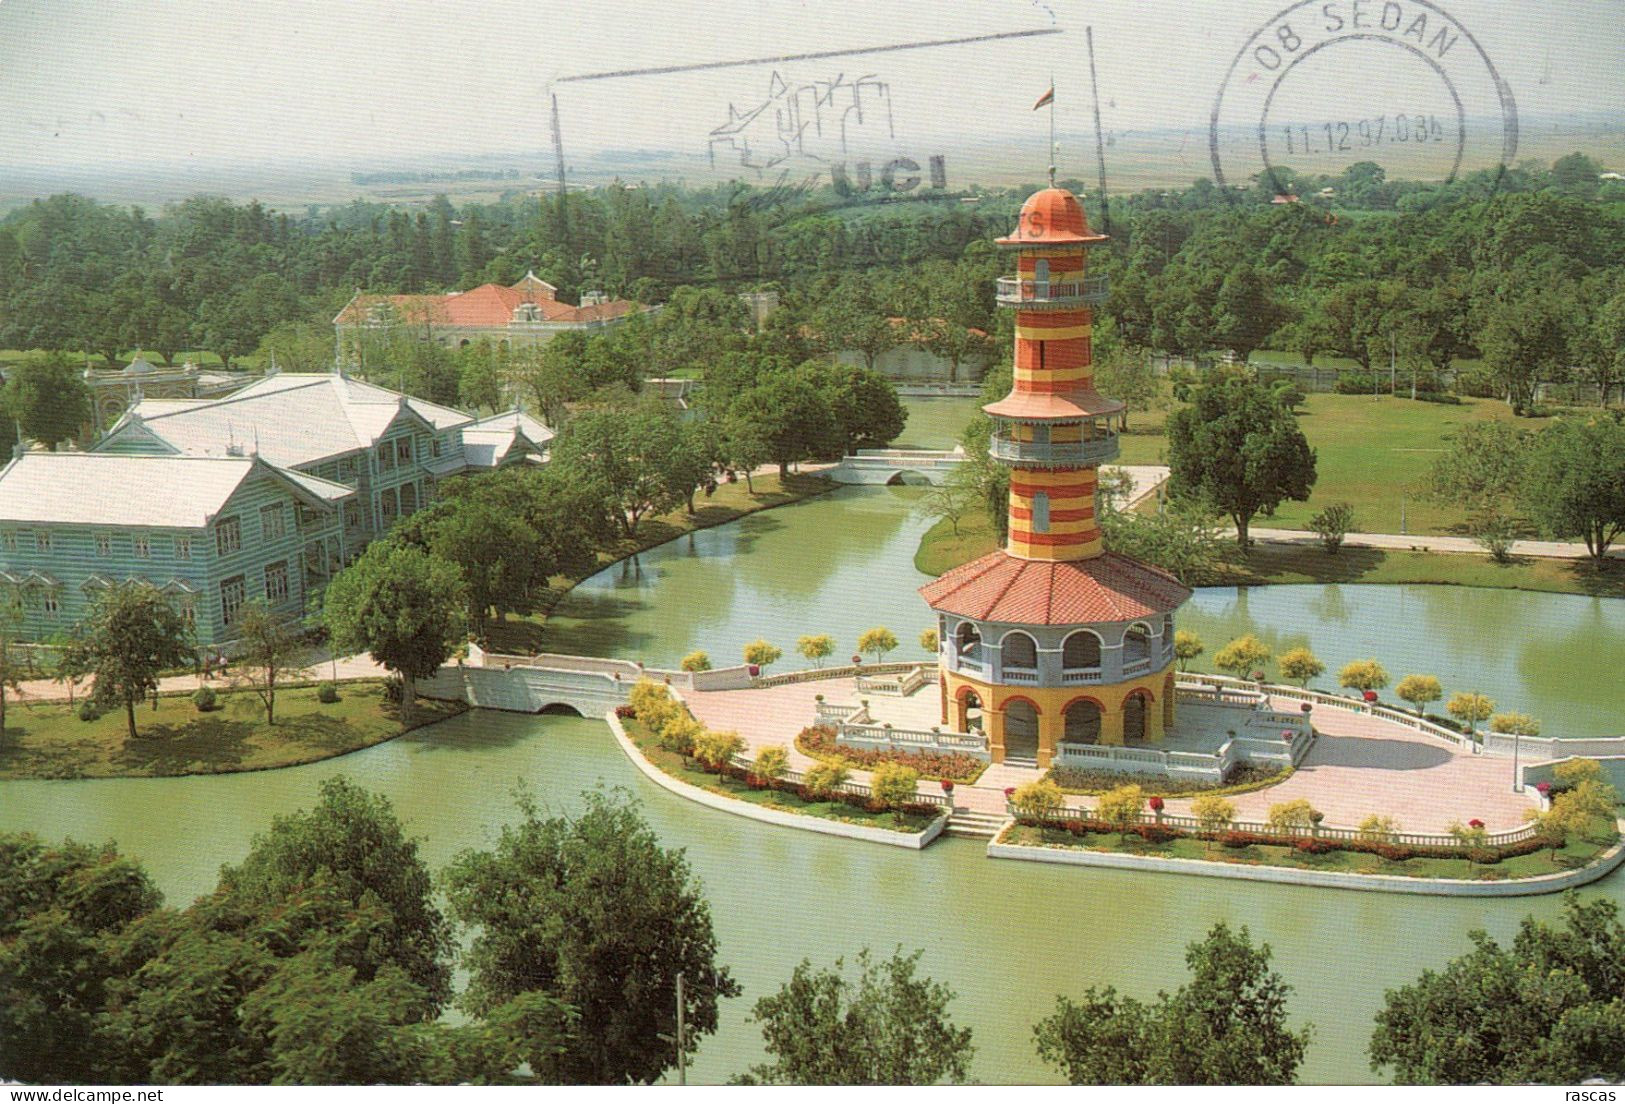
[920,551,1191,624]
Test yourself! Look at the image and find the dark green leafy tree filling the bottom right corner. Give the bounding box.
[1370,891,1625,1084]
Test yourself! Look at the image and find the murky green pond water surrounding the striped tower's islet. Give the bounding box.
[0,488,1625,1083]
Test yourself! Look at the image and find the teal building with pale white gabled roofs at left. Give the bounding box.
[0,374,553,652]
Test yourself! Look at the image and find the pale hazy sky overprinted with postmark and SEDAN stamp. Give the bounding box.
[0,0,1625,167]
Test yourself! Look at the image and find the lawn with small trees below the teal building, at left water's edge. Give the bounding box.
[0,681,466,779]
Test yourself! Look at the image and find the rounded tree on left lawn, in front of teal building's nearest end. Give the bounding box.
[67,582,192,740]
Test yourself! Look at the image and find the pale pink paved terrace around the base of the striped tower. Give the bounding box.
[684,678,1534,832]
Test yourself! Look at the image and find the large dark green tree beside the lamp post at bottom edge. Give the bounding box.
[445,792,739,1084]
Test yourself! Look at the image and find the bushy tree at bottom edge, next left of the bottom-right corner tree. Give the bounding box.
[1034,924,1313,1084]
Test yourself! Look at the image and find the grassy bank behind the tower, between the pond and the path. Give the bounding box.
[915,514,1625,598]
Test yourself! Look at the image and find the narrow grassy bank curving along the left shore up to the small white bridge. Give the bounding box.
[486,473,837,655]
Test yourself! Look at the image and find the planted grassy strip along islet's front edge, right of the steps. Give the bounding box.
[998,821,1619,881]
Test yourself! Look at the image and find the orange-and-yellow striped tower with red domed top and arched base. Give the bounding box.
[920,187,1191,767]
